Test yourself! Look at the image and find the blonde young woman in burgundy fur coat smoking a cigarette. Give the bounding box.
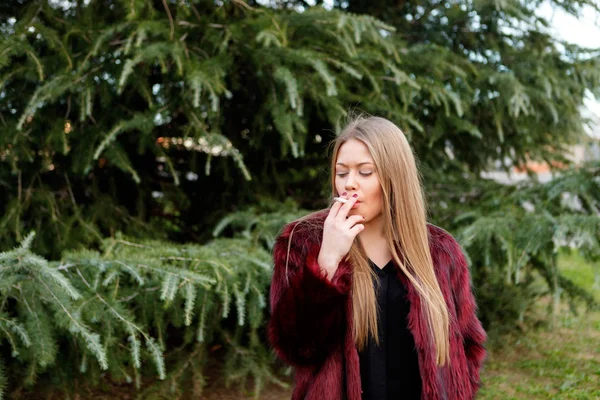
[268,117,486,400]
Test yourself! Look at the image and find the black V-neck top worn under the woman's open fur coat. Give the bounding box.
[359,261,421,400]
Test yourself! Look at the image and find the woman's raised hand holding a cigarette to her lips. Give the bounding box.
[317,197,365,280]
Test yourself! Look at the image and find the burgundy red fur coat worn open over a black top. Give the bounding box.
[268,212,486,400]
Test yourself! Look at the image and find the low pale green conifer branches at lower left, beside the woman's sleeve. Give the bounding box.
[0,234,277,398]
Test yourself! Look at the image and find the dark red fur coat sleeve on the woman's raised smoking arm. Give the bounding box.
[268,217,351,366]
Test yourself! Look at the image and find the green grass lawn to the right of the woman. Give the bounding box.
[478,253,600,400]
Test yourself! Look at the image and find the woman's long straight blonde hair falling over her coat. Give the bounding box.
[331,116,450,366]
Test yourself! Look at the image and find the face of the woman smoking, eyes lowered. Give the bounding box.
[335,139,383,223]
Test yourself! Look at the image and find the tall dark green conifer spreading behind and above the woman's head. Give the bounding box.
[0,0,600,253]
